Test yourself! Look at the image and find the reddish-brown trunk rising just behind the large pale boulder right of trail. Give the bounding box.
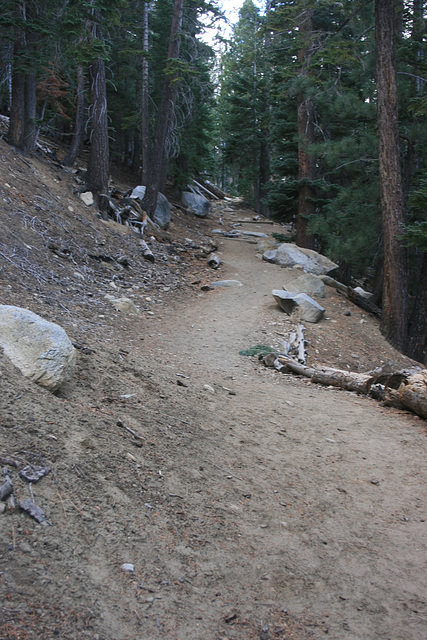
[297,8,316,249]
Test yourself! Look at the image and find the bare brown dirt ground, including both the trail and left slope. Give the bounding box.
[0,141,427,640]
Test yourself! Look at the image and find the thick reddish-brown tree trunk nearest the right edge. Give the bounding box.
[375,0,408,351]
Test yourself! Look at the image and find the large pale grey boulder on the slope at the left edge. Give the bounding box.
[0,305,76,391]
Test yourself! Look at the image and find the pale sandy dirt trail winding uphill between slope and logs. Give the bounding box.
[144,212,427,640]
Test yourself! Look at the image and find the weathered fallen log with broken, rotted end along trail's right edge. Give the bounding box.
[270,354,427,419]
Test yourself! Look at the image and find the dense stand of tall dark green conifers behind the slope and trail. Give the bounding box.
[0,0,427,362]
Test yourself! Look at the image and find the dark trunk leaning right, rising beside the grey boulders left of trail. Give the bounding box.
[141,0,183,216]
